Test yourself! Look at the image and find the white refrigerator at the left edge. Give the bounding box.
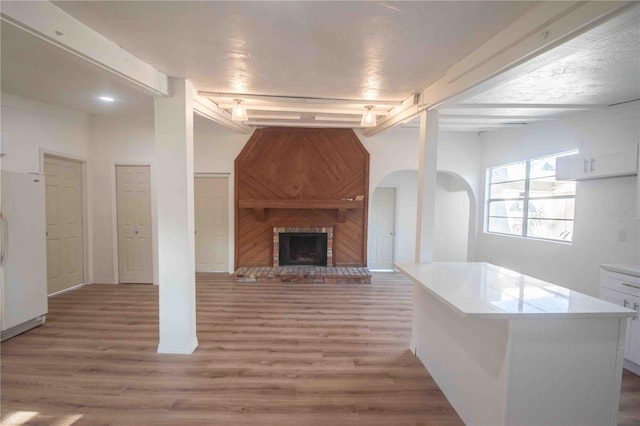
[0,171,47,341]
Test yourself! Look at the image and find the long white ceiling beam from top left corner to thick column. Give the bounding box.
[0,1,169,96]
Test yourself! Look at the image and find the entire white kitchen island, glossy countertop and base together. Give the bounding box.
[396,263,634,425]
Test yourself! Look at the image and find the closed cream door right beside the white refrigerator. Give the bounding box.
[44,156,84,294]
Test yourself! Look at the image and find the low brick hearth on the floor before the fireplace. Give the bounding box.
[231,265,371,284]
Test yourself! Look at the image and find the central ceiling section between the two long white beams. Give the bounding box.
[54,1,534,100]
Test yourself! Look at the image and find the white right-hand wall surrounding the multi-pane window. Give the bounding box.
[477,102,640,296]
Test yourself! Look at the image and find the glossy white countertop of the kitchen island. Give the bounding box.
[396,262,635,319]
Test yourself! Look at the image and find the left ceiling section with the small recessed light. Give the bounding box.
[0,22,153,114]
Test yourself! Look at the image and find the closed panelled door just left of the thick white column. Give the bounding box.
[116,166,153,283]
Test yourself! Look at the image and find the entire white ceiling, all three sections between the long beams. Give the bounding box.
[1,1,640,131]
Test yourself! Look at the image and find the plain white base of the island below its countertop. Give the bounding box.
[411,284,627,426]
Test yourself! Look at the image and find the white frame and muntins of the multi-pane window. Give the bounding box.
[484,150,578,244]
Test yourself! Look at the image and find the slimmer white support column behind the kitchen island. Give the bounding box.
[416,110,438,263]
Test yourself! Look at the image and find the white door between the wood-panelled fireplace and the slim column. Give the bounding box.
[368,188,396,270]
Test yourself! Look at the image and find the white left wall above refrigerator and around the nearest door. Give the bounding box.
[0,93,93,282]
